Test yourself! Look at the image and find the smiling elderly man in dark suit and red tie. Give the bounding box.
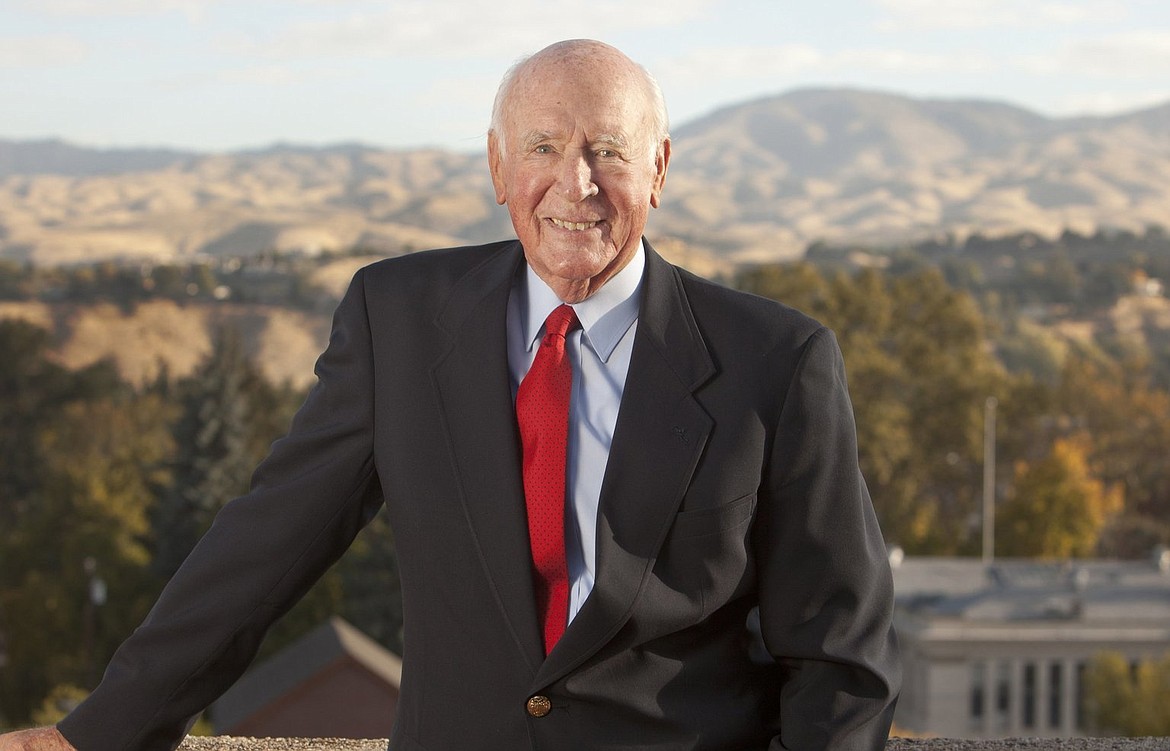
[0,41,899,751]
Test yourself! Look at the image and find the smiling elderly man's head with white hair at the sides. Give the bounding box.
[488,40,670,302]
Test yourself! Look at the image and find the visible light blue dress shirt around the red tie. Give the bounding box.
[508,246,646,621]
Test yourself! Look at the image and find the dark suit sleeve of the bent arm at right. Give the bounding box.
[755,329,901,751]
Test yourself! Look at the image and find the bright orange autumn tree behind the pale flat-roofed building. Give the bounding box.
[997,435,1123,558]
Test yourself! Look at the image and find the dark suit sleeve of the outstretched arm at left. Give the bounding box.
[59,266,381,751]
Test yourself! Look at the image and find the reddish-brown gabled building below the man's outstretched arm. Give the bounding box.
[211,618,402,738]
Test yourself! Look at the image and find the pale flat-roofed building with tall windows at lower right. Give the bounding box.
[892,551,1170,738]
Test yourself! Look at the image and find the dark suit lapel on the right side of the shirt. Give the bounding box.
[535,243,715,687]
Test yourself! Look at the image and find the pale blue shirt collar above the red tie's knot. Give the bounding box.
[521,242,646,363]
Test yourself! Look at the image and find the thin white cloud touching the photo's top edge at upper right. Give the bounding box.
[875,0,1129,32]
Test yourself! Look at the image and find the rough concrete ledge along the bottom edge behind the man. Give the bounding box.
[179,736,1170,751]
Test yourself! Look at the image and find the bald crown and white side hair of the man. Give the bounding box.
[489,39,669,156]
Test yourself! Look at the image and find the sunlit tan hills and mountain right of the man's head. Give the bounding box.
[662,89,1170,261]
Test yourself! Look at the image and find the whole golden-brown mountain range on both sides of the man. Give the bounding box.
[0,89,1170,273]
